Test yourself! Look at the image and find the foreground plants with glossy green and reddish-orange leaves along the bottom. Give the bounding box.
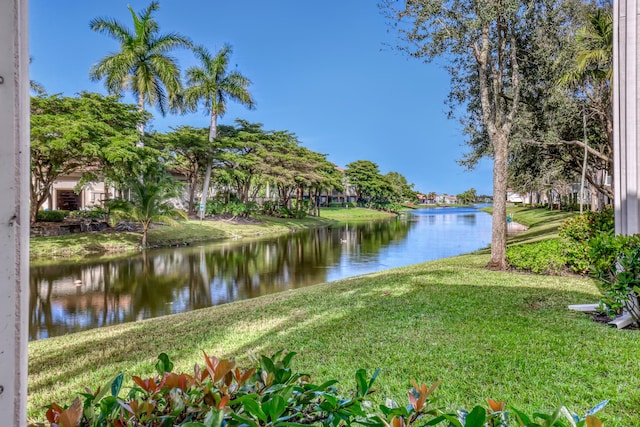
[37,351,607,427]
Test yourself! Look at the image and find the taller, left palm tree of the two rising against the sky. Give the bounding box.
[89,1,191,134]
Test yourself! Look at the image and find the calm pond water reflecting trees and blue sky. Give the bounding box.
[29,208,491,340]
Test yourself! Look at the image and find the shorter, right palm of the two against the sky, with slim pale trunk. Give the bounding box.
[184,45,255,219]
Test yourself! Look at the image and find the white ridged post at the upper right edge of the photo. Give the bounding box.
[613,0,640,234]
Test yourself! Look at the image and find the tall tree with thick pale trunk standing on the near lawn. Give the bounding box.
[382,0,528,269]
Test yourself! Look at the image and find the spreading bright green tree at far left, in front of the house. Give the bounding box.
[31,93,147,222]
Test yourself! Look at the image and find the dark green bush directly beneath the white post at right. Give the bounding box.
[590,233,640,325]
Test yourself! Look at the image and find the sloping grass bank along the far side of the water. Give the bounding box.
[29,208,393,263]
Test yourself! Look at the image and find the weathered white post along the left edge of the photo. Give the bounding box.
[0,0,29,427]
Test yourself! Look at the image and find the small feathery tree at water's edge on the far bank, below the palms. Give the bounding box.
[109,164,187,248]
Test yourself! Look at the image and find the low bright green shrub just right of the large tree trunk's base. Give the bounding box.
[507,239,567,274]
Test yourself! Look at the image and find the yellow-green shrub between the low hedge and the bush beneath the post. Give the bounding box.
[559,209,614,273]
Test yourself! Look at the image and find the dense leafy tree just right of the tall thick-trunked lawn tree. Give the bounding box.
[500,0,606,211]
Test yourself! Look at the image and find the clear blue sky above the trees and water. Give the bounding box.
[29,0,492,194]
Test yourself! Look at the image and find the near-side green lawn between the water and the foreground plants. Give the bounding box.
[28,207,640,426]
